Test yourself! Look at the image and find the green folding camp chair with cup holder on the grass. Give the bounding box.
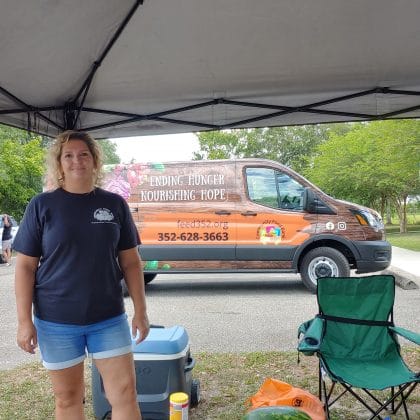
[298,275,420,419]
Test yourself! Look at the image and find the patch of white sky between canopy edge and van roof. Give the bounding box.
[111,133,199,163]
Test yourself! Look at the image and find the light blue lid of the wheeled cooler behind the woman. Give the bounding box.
[133,325,189,354]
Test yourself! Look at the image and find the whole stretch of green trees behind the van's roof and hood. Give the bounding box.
[194,120,420,231]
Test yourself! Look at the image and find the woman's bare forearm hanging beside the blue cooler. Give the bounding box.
[118,247,149,344]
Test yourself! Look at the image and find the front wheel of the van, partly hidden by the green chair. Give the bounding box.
[300,247,350,293]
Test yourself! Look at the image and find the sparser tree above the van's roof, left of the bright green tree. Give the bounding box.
[194,124,338,172]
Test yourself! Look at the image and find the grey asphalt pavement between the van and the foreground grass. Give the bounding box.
[0,265,420,369]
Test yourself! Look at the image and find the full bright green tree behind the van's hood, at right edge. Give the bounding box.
[305,120,420,232]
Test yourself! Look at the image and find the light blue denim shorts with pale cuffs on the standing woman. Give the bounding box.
[34,313,132,370]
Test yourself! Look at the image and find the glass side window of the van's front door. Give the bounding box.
[246,168,304,210]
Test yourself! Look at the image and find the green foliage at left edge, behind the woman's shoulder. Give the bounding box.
[0,126,44,220]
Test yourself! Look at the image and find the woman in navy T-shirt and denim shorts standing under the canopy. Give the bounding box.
[14,131,149,420]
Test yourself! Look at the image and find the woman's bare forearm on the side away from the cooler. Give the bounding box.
[15,253,39,353]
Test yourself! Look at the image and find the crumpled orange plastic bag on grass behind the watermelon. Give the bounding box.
[247,378,325,420]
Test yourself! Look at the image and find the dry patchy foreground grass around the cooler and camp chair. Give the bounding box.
[0,346,420,420]
